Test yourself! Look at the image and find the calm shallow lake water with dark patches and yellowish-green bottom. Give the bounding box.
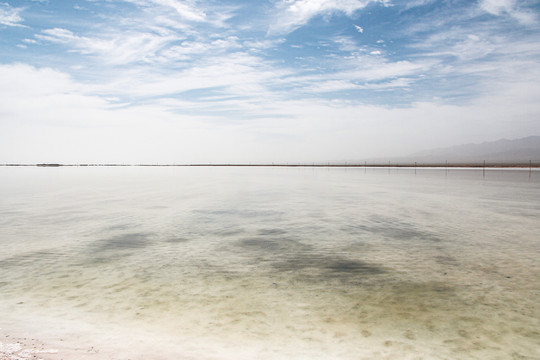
[0,167,540,359]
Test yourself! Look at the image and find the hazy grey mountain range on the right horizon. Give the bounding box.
[386,136,540,164]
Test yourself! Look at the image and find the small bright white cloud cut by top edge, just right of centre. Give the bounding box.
[269,0,385,34]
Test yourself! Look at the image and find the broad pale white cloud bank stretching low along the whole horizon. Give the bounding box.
[0,62,540,163]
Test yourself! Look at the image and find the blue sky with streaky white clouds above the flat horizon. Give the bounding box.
[0,0,540,163]
